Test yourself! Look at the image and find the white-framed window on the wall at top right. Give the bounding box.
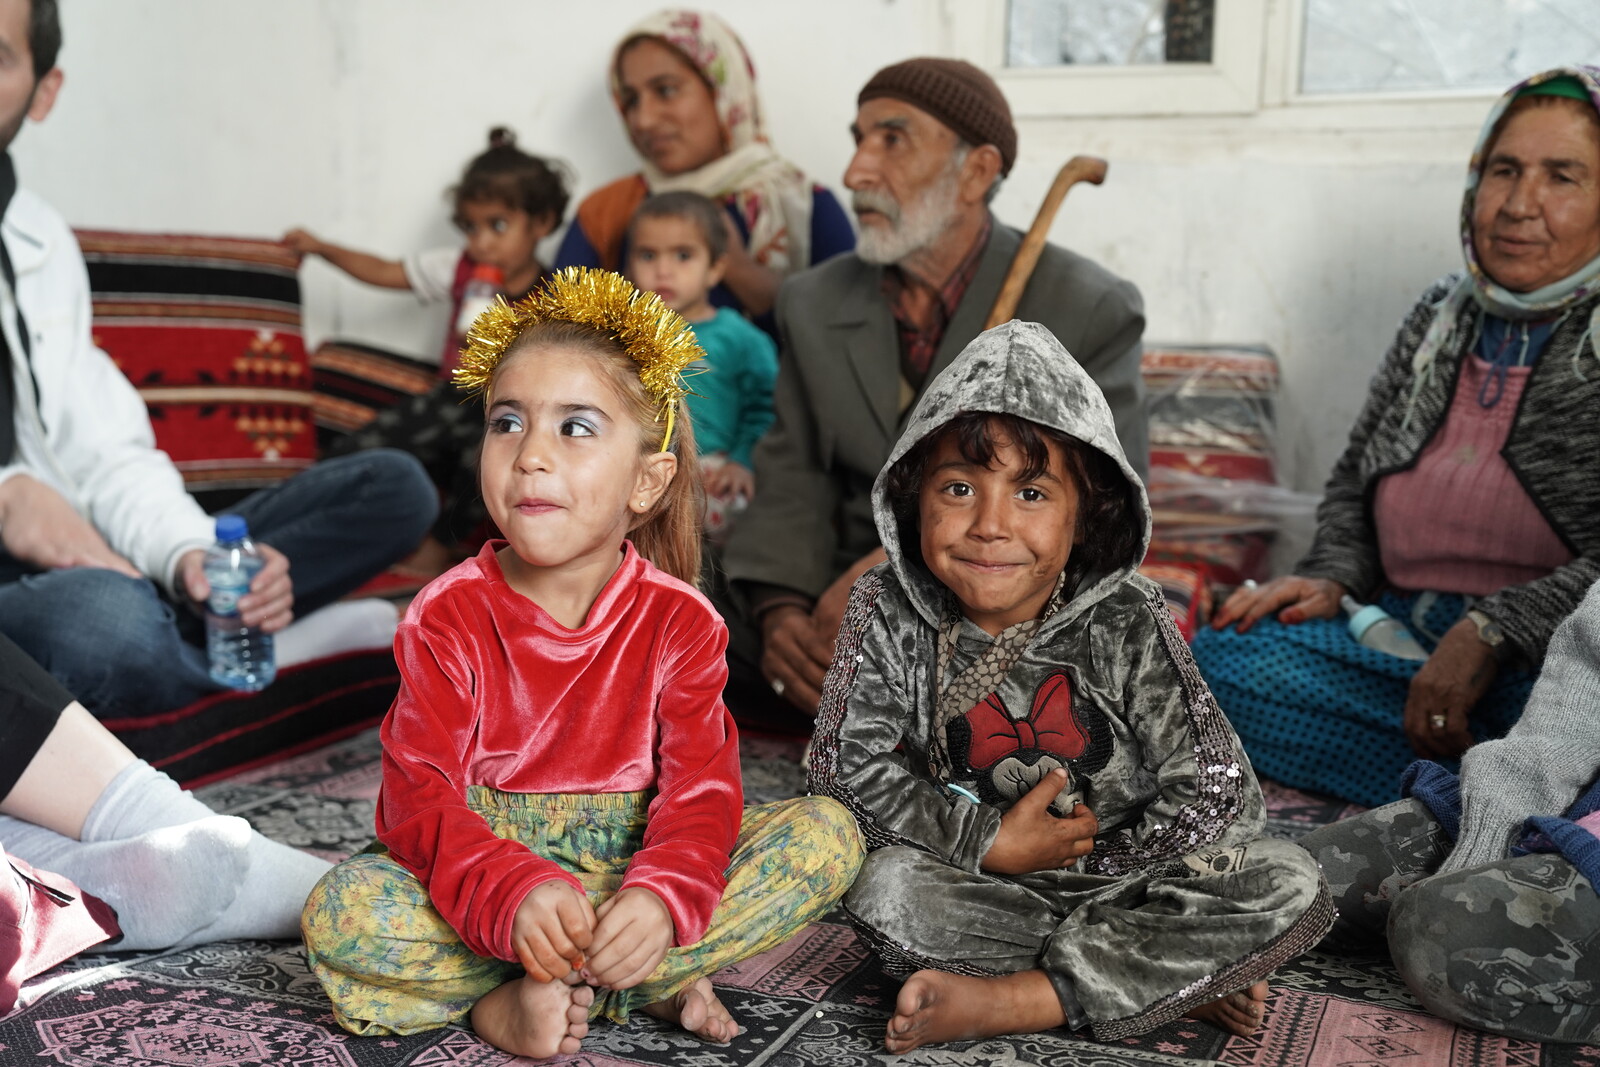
[942,0,1600,118]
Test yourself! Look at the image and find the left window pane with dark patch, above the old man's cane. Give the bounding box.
[1006,0,1216,67]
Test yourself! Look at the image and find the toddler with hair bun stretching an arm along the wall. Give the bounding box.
[283,126,568,574]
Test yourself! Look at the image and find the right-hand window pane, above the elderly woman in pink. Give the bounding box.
[1301,0,1600,93]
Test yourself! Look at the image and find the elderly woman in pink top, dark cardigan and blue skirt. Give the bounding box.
[1194,67,1600,805]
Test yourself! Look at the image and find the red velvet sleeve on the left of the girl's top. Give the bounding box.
[378,604,582,961]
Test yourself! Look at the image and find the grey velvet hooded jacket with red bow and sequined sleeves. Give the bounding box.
[811,322,1264,875]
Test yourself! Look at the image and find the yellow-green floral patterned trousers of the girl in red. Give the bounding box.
[301,785,862,1035]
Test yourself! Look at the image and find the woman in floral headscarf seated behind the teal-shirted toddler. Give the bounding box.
[555,10,856,318]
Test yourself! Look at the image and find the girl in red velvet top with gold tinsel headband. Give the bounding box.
[304,269,861,1056]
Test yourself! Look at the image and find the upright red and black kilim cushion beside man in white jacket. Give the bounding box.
[78,230,317,510]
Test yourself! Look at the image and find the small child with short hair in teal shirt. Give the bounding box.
[627,192,778,542]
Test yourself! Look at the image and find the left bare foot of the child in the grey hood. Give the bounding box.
[883,971,1067,1054]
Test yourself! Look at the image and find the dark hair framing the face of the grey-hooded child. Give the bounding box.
[885,411,1144,590]
